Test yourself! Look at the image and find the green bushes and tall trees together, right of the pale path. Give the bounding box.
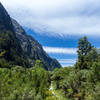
[51,37,100,100]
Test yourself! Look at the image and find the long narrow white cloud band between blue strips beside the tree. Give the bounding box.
[43,47,77,54]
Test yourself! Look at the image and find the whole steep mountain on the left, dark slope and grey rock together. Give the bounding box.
[0,3,61,70]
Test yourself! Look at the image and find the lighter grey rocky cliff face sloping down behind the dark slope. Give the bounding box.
[12,19,61,70]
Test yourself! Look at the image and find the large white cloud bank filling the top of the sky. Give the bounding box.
[1,0,100,36]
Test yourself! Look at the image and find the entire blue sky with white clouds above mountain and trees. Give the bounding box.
[0,0,100,66]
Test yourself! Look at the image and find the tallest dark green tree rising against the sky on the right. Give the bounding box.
[76,36,93,69]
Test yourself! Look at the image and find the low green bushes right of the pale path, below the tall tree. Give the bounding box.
[52,66,100,100]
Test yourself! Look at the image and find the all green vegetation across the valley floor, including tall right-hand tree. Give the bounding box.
[0,37,100,100]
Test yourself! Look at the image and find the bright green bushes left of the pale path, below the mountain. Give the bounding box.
[0,66,49,100]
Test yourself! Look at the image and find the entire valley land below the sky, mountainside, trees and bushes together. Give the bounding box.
[0,3,100,100]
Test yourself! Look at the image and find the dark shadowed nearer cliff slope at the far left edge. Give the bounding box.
[0,3,29,67]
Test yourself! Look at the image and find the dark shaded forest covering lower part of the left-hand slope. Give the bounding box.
[0,31,29,67]
